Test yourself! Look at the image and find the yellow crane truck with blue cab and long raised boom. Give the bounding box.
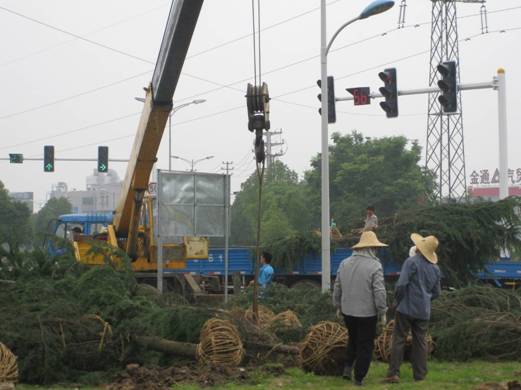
[48,0,208,272]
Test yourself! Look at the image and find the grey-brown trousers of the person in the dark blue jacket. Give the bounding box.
[388,311,429,380]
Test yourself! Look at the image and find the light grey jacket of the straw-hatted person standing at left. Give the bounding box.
[333,252,387,317]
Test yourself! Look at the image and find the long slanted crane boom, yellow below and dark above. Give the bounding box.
[113,0,204,257]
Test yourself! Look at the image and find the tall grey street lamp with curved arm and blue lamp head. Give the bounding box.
[320,0,394,292]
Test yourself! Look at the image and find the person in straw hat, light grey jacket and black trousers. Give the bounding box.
[333,231,387,385]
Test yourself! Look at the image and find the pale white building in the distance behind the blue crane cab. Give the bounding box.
[50,169,122,213]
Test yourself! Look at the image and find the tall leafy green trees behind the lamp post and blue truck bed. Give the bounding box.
[232,132,433,267]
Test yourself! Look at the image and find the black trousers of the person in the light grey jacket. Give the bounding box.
[344,315,377,381]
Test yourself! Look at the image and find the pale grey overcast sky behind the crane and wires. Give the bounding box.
[0,0,521,208]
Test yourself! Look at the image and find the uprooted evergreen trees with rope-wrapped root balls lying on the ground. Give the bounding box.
[4,251,521,384]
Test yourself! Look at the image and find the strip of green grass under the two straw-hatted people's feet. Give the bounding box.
[16,361,521,390]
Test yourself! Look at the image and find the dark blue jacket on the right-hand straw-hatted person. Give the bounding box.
[394,254,441,320]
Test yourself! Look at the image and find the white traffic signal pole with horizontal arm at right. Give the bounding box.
[335,68,508,199]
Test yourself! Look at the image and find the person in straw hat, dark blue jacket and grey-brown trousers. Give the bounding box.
[385,233,441,383]
